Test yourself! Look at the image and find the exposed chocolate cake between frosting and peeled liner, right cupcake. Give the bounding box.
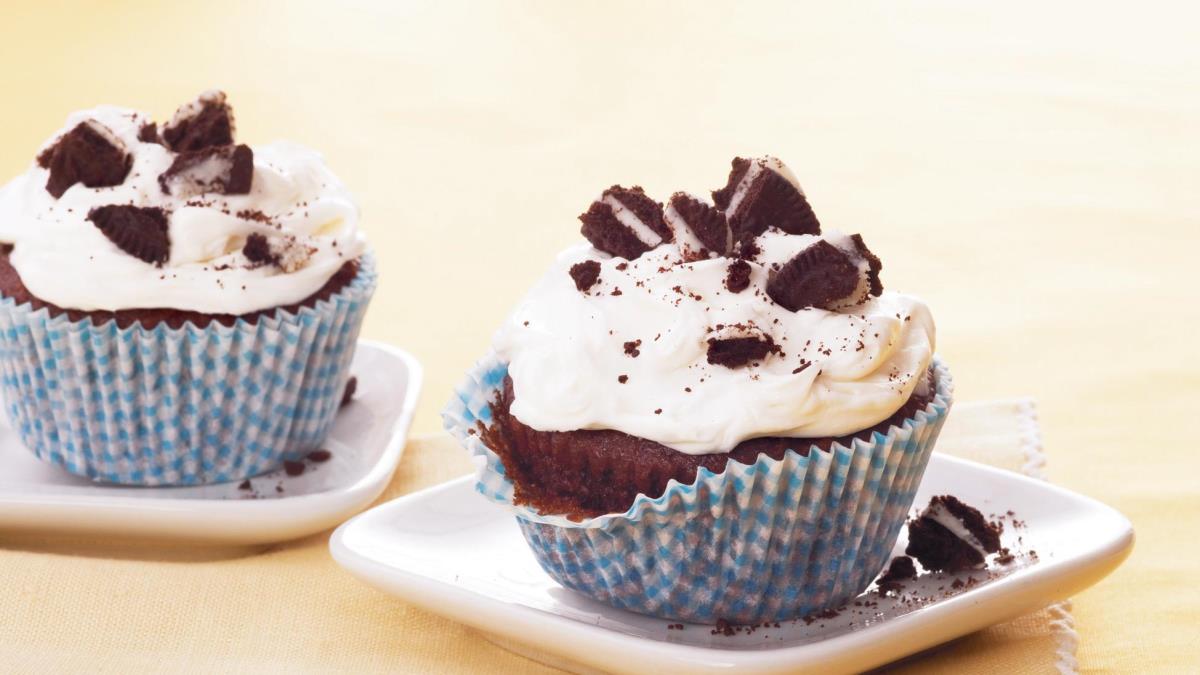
[479,372,934,519]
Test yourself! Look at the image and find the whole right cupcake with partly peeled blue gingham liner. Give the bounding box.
[444,157,952,623]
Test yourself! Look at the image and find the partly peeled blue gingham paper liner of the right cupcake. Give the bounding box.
[443,354,953,623]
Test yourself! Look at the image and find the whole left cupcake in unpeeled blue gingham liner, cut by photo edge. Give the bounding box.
[0,91,376,485]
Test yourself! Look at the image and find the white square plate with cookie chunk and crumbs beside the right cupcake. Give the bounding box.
[330,453,1133,673]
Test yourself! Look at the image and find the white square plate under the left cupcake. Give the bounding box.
[0,341,421,544]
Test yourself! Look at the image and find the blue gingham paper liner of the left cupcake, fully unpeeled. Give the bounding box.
[0,253,376,485]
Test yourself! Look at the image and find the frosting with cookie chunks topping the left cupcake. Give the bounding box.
[0,91,366,315]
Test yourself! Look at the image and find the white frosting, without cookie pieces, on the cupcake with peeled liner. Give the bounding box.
[494,229,934,454]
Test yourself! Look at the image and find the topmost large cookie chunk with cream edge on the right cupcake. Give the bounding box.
[713,157,821,241]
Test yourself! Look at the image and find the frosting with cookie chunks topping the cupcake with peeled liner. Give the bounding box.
[493,157,934,454]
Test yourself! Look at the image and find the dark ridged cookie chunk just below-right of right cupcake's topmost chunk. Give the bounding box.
[767,239,862,312]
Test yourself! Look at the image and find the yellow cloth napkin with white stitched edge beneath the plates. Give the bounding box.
[0,402,1060,673]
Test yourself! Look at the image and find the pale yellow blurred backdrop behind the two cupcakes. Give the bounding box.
[0,1,1200,671]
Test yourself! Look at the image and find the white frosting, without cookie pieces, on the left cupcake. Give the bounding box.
[0,106,366,315]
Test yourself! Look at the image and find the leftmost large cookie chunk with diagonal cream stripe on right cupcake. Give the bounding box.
[580,185,673,261]
